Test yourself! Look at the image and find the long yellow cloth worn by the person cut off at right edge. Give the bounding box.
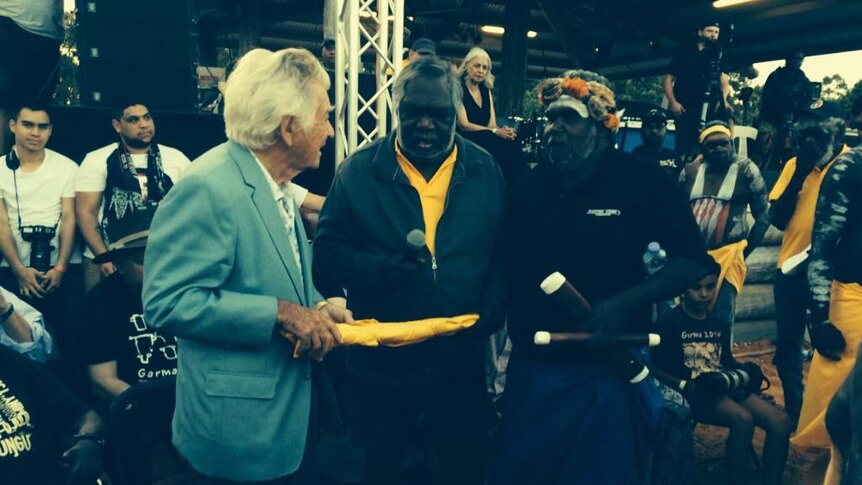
[790,281,862,448]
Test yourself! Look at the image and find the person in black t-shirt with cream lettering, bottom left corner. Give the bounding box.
[0,345,104,485]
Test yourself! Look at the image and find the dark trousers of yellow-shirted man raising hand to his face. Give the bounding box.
[772,269,811,425]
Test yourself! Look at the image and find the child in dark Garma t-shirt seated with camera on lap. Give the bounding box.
[653,264,790,485]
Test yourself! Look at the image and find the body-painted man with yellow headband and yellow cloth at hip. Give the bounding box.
[679,121,769,328]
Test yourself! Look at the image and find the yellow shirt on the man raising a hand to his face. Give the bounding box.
[769,145,850,268]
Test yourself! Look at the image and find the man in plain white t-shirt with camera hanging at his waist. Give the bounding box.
[0,103,80,360]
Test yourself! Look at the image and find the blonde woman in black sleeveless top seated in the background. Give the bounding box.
[458,47,526,187]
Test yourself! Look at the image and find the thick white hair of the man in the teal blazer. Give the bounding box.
[224,49,329,150]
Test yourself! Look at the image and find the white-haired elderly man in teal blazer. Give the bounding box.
[143,49,352,484]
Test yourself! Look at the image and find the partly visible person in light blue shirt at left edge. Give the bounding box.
[0,287,54,364]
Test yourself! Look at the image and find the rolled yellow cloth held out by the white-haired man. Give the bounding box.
[293,313,479,357]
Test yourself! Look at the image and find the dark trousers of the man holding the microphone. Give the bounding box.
[347,362,490,485]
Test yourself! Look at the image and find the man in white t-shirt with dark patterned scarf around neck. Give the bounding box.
[75,102,191,290]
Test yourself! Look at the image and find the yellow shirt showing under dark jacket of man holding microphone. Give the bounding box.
[395,140,458,256]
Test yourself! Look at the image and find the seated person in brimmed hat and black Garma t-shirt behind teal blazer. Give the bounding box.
[76,206,177,485]
